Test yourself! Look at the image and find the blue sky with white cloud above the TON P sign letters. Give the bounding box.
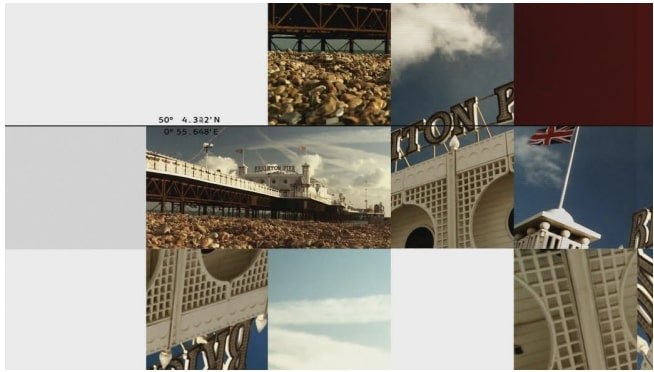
[391,4,513,169]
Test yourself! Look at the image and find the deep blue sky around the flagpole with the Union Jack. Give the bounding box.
[514,126,652,248]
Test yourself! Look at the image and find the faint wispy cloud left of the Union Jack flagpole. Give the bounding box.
[515,136,564,186]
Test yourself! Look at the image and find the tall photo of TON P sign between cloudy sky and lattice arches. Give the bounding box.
[391,4,515,248]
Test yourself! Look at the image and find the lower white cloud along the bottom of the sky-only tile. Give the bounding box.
[268,327,391,370]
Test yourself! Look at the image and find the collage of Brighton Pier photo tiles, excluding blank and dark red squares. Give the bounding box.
[144,3,654,370]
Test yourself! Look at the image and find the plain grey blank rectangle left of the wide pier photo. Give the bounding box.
[5,127,145,249]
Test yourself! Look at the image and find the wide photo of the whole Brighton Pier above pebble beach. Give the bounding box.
[146,126,390,249]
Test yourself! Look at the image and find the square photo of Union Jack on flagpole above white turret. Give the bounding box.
[514,126,653,249]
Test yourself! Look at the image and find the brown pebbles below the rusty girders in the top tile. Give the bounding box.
[268,51,391,125]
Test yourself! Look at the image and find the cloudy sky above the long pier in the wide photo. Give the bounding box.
[147,127,390,214]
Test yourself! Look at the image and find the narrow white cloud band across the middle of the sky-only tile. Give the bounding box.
[268,295,391,326]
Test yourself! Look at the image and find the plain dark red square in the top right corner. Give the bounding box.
[515,3,652,127]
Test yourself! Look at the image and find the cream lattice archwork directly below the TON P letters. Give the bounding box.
[391,131,514,248]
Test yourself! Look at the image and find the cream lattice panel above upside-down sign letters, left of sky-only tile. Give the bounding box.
[146,249,268,353]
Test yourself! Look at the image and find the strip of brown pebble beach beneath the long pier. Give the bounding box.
[146,213,391,249]
